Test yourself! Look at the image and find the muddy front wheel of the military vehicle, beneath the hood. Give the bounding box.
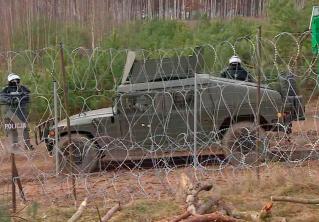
[58,134,98,174]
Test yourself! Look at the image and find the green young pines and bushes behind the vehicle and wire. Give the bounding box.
[0,0,319,119]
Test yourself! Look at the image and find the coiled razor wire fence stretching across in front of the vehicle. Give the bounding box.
[0,33,319,220]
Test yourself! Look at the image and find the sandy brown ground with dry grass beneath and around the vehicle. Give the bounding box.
[0,103,319,221]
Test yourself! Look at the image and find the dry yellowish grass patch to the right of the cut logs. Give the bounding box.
[215,164,319,221]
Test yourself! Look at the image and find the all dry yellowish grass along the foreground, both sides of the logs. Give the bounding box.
[13,162,319,222]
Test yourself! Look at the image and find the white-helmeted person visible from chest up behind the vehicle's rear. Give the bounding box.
[221,56,252,82]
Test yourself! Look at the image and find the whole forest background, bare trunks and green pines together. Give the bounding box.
[0,0,315,118]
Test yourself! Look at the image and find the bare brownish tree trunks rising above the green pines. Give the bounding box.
[0,0,312,51]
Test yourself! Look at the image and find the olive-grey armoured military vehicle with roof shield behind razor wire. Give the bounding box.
[38,52,304,172]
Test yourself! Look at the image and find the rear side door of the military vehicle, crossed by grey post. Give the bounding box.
[165,88,215,145]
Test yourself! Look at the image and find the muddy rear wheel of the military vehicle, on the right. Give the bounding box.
[222,122,267,166]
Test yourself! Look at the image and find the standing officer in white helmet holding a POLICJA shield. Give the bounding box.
[0,73,33,150]
